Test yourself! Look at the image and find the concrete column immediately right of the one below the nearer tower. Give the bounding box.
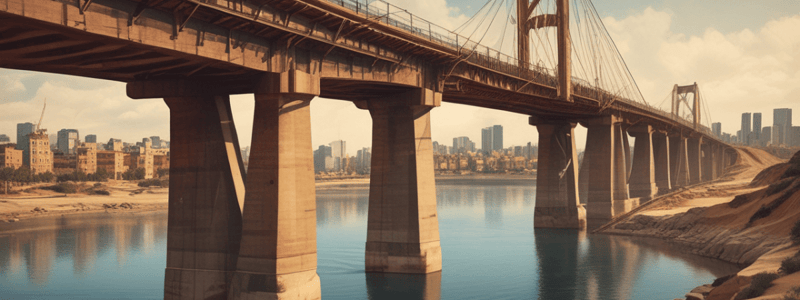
[584,116,638,222]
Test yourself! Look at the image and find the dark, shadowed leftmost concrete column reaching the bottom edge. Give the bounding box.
[164,95,244,299]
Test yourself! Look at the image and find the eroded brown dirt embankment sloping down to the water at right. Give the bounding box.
[603,148,800,299]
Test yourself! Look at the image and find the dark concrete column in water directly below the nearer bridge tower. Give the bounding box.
[531,117,586,229]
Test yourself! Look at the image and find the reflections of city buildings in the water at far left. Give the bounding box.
[0,212,167,288]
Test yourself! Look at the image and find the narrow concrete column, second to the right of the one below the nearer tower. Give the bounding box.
[628,125,658,200]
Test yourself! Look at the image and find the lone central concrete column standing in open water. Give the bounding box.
[356,90,442,273]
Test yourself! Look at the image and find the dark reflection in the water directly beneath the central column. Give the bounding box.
[366,272,442,300]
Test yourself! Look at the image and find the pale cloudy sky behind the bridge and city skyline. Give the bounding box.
[0,0,800,155]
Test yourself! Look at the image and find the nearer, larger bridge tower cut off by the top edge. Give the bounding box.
[517,0,572,102]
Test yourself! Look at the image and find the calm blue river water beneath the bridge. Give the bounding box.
[0,181,737,300]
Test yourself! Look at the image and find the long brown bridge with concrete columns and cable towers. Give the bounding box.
[0,0,736,299]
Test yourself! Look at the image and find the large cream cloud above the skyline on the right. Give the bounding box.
[603,8,800,134]
